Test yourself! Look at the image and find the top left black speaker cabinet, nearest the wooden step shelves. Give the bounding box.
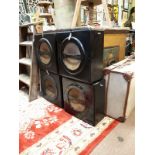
[34,31,58,74]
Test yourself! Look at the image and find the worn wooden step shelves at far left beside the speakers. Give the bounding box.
[19,22,40,101]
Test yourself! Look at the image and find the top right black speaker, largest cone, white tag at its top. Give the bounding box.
[56,28,104,83]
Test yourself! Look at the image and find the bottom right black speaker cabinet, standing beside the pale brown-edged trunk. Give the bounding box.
[62,78,104,125]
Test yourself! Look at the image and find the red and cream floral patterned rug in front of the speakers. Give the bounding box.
[19,98,118,155]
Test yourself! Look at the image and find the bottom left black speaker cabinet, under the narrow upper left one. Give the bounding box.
[40,71,63,108]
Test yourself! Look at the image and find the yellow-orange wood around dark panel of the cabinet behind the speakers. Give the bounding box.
[104,33,127,61]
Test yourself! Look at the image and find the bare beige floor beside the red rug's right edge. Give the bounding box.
[90,111,135,155]
